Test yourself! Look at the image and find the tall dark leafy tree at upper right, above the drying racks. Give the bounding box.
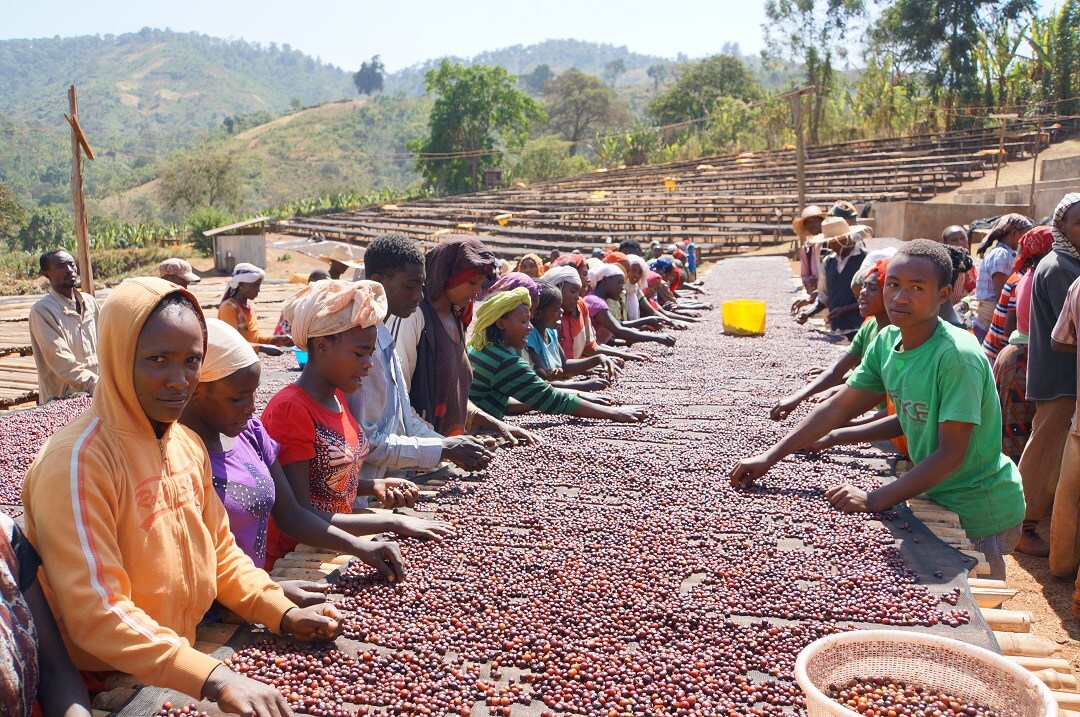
[873,0,1035,130]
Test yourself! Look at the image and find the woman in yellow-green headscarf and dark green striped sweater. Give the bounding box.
[469,288,645,423]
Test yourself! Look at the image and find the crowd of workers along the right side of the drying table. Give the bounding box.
[743,193,1080,591]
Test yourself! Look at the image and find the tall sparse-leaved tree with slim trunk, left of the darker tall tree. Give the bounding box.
[762,0,866,145]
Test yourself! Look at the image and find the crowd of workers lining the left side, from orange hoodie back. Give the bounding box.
[12,226,711,717]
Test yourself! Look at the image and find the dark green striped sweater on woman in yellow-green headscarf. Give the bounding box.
[469,346,581,418]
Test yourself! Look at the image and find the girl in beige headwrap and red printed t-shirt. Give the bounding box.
[262,280,429,565]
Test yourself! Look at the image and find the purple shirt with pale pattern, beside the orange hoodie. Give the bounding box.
[210,418,280,567]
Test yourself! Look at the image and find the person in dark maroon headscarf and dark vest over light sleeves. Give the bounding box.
[387,235,535,442]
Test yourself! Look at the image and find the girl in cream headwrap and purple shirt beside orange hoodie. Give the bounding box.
[180,319,450,587]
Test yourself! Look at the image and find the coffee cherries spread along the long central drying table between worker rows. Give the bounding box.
[225,259,969,717]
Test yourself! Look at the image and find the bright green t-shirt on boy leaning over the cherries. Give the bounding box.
[848,319,1024,538]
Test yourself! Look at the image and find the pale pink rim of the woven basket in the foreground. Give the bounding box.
[795,630,1059,717]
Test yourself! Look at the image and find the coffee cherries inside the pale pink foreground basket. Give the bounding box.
[828,677,1016,717]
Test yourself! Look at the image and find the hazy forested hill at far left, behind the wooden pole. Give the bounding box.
[0,28,355,202]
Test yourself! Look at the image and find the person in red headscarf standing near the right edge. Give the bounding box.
[983,227,1054,462]
